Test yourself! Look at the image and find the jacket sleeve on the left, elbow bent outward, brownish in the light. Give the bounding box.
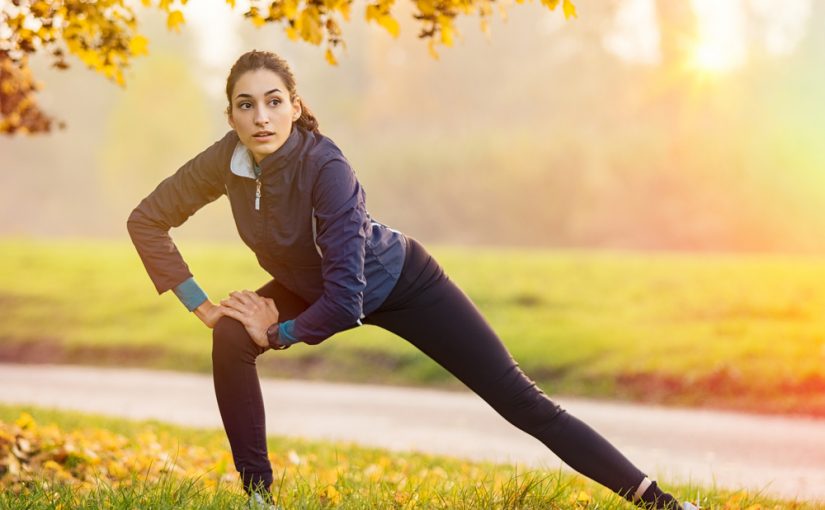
[126,133,231,294]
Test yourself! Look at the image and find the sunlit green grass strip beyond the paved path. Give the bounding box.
[0,238,825,416]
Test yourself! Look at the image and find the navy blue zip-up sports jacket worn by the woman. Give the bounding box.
[127,124,406,344]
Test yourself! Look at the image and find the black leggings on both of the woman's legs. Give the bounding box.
[212,237,675,507]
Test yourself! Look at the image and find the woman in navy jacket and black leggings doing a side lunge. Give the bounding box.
[127,51,693,508]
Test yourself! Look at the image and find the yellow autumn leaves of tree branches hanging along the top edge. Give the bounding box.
[0,0,576,134]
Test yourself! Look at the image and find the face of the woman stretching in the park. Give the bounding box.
[229,69,301,163]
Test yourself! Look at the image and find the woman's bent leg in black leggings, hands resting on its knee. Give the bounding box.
[212,280,309,493]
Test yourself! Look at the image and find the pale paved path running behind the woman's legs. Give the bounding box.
[0,363,825,503]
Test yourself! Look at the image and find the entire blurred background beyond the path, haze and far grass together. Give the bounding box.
[0,0,825,416]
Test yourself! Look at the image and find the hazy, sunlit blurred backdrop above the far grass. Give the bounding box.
[0,0,825,254]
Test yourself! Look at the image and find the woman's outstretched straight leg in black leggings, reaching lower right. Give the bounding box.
[364,239,678,507]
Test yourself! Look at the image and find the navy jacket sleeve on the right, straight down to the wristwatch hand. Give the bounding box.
[292,159,370,344]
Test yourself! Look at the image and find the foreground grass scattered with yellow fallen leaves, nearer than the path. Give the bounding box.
[0,404,817,510]
